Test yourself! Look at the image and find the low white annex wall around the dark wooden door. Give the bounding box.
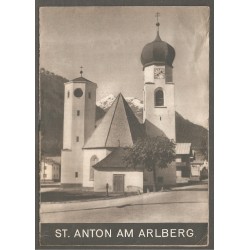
[94,170,143,192]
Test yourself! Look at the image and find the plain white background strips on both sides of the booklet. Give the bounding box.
[0,0,250,249]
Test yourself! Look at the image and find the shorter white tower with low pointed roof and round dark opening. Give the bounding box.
[61,67,97,185]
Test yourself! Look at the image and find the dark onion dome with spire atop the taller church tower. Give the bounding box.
[141,22,175,68]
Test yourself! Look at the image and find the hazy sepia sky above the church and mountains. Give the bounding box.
[40,6,209,127]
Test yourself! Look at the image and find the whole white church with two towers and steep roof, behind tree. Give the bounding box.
[61,18,191,192]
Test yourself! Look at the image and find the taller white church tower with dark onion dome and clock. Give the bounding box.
[141,13,176,141]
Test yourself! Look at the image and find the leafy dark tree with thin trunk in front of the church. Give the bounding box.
[123,136,175,192]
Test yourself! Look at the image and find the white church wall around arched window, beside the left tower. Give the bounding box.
[82,148,112,187]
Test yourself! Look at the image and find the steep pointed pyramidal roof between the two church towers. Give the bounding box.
[84,94,144,148]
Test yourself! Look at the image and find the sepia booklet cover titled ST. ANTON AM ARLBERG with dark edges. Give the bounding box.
[36,0,214,249]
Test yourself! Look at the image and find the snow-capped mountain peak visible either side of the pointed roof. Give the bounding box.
[96,94,143,122]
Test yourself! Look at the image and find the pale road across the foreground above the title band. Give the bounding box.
[40,185,208,223]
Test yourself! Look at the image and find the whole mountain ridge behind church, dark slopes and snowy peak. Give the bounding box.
[39,69,208,156]
